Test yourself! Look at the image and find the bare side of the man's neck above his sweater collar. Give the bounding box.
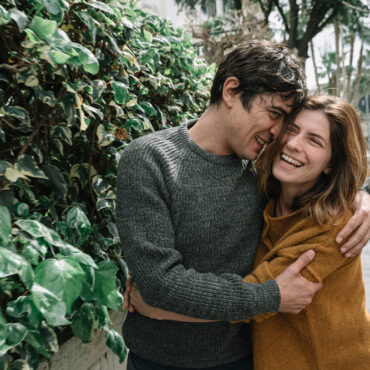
[189,103,233,156]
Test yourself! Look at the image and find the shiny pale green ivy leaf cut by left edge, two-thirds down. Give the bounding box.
[0,247,34,288]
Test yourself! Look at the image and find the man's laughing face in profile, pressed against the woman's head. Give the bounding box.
[226,93,294,160]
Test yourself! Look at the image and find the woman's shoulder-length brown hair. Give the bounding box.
[256,96,367,224]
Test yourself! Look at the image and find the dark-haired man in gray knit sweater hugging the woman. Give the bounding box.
[117,42,369,370]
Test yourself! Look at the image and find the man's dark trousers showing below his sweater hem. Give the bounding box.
[127,351,253,370]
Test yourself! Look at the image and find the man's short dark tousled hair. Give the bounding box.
[210,41,307,110]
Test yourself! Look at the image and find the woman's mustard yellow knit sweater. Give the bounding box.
[244,201,370,370]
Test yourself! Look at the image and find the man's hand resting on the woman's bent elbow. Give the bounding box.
[276,250,322,314]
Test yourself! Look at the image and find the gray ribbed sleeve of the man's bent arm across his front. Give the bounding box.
[117,129,280,321]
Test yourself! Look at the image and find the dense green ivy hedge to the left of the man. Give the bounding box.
[0,0,210,369]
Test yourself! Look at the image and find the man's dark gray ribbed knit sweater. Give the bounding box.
[117,123,280,368]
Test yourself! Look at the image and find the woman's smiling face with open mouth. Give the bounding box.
[272,110,332,196]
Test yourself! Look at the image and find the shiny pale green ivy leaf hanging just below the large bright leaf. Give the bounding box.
[31,283,70,326]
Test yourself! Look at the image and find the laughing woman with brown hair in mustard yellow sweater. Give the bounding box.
[128,96,370,370]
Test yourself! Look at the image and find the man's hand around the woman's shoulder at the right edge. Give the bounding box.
[335,190,370,257]
